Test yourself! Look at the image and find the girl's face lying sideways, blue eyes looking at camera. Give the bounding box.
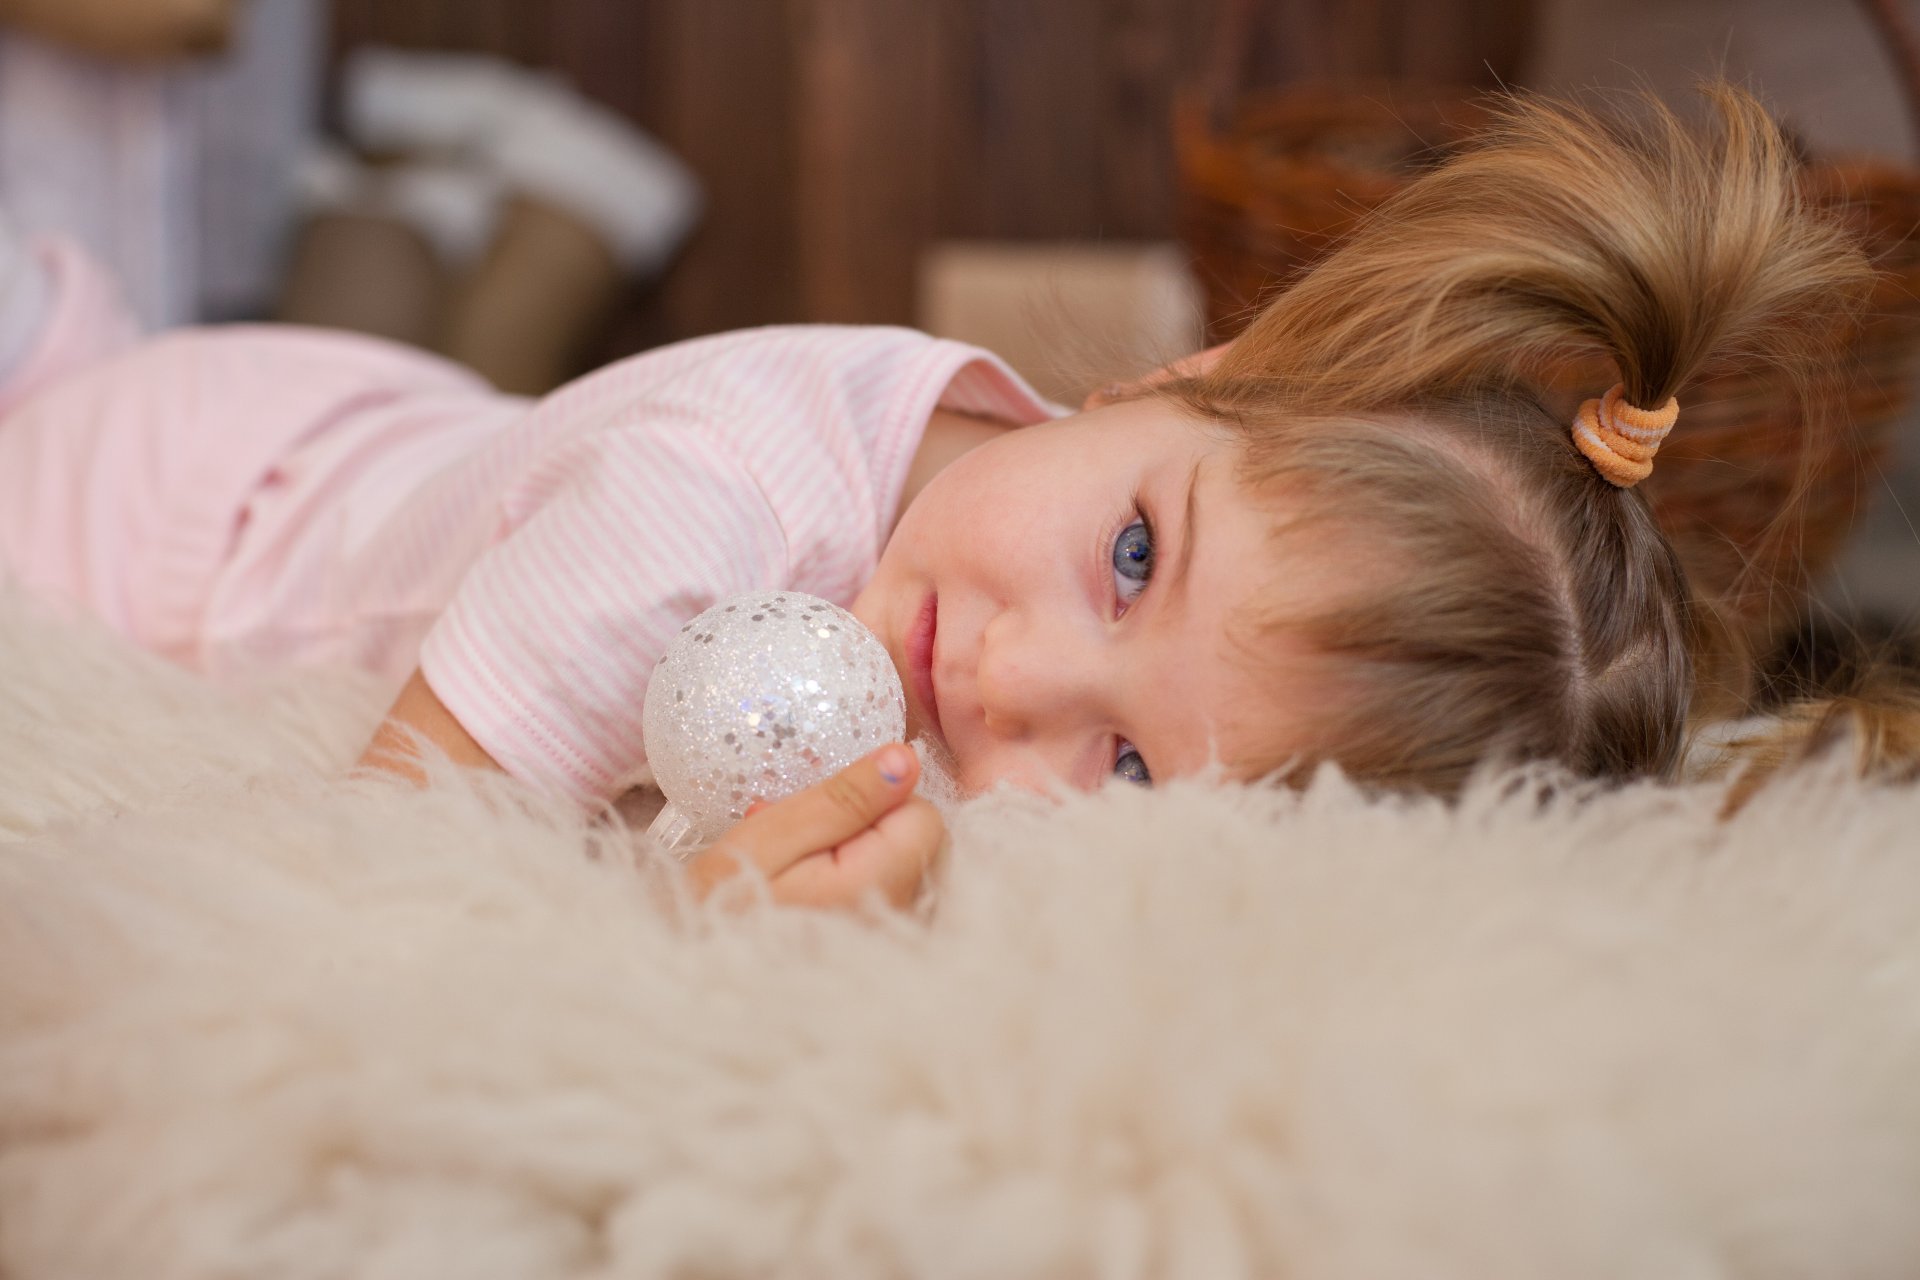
[852,399,1308,791]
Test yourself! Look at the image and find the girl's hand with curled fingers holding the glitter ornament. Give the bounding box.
[685,743,947,906]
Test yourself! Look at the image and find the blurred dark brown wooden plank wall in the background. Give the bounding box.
[334,0,1530,355]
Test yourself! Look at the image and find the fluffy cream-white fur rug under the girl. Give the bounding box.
[0,594,1920,1280]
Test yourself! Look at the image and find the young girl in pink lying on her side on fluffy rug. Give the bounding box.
[0,86,1870,902]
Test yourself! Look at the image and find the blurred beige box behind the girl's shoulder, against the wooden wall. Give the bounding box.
[918,242,1204,405]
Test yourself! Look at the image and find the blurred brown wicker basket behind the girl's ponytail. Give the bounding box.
[1177,67,1920,645]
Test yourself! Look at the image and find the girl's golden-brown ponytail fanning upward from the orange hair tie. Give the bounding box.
[1213,84,1872,418]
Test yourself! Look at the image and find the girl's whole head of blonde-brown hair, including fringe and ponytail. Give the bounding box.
[1156,84,1872,791]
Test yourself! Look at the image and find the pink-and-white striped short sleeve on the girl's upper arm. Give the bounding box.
[420,426,787,808]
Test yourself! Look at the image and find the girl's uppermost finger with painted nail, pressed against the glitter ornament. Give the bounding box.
[687,743,920,890]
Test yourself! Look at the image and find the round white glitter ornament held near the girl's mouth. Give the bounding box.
[641,591,906,856]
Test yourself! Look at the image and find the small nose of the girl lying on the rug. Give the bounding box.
[975,608,1104,741]
